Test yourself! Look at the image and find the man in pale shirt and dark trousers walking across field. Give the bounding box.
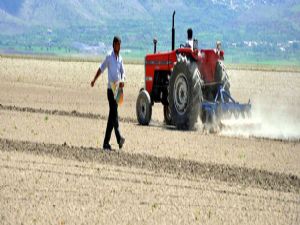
[91,36,125,150]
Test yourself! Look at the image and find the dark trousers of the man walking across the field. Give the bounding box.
[104,89,121,144]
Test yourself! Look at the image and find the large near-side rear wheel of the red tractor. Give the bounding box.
[168,56,202,130]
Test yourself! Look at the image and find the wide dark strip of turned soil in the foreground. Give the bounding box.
[0,139,300,193]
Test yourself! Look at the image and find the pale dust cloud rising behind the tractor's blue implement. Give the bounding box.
[220,100,300,141]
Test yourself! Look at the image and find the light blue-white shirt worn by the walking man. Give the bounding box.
[100,50,125,89]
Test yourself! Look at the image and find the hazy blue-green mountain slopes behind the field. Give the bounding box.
[0,0,300,62]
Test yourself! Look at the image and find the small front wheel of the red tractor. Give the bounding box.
[136,90,152,125]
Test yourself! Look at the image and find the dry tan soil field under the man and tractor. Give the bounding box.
[0,57,300,224]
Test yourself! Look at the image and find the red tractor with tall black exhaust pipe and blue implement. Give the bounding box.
[136,11,250,130]
